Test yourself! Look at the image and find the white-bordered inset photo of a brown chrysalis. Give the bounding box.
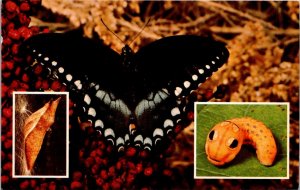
[13,92,69,178]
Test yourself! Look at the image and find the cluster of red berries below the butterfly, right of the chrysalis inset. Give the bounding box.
[71,127,173,189]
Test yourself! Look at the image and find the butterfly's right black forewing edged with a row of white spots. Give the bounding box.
[135,35,229,96]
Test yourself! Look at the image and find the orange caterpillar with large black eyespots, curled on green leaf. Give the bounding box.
[205,117,277,166]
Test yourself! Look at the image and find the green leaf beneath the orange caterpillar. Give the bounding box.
[195,103,288,178]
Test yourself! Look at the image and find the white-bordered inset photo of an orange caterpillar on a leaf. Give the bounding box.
[194,102,289,179]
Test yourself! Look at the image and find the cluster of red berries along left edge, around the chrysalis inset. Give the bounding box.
[1,0,69,189]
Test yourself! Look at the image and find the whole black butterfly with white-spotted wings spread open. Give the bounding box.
[20,32,229,154]
